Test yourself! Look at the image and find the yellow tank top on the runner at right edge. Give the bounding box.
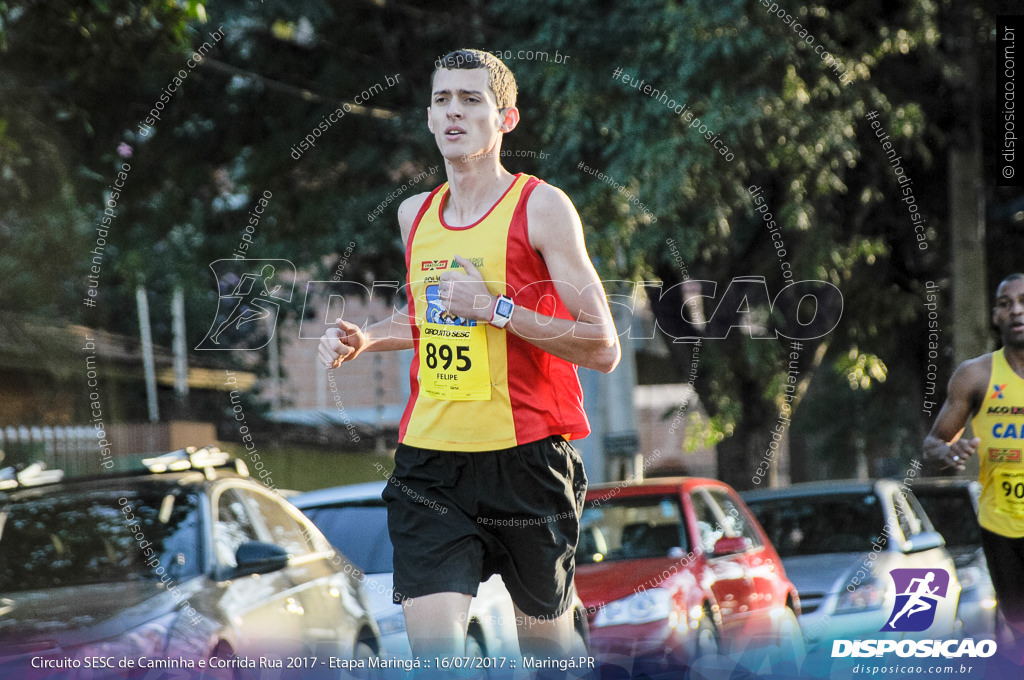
[971,349,1024,539]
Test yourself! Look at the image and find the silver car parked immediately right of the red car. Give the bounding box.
[742,479,961,647]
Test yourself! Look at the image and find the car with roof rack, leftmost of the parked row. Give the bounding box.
[0,449,380,678]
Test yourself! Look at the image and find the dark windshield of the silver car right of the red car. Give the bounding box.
[746,493,885,557]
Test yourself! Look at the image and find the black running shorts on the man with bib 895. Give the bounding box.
[382,436,587,617]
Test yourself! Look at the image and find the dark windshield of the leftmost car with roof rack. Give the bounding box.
[0,486,202,593]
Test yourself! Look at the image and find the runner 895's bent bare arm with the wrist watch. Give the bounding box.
[441,184,621,373]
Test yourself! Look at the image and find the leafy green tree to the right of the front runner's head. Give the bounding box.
[502,1,981,487]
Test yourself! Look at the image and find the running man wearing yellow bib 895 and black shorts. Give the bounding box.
[319,50,620,657]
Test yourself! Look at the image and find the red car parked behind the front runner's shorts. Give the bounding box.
[575,477,804,670]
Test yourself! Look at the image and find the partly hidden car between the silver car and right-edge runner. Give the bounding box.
[913,477,996,637]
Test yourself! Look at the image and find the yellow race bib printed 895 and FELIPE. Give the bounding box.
[420,323,490,401]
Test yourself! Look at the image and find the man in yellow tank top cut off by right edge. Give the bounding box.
[925,273,1024,641]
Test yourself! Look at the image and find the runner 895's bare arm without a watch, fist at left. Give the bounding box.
[317,194,428,369]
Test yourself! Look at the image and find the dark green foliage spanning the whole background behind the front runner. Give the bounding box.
[0,0,1003,478]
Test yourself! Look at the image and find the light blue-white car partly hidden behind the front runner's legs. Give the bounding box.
[291,480,589,658]
